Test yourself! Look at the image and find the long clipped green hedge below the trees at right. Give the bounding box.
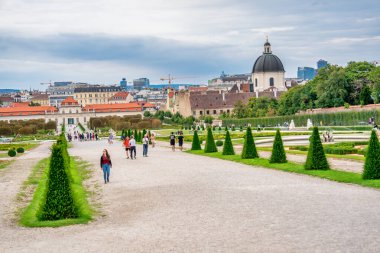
[223,110,380,127]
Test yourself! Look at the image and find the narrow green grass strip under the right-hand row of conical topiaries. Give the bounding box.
[186,150,380,188]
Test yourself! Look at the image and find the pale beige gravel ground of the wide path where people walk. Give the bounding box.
[0,141,380,253]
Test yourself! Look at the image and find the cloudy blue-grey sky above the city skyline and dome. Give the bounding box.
[0,0,380,89]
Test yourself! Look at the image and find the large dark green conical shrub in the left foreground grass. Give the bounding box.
[39,144,77,220]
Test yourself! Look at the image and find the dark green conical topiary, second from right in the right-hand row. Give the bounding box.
[305,127,330,170]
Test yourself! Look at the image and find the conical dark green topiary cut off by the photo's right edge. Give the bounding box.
[363,130,380,179]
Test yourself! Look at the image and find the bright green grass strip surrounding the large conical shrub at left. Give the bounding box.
[19,157,94,227]
